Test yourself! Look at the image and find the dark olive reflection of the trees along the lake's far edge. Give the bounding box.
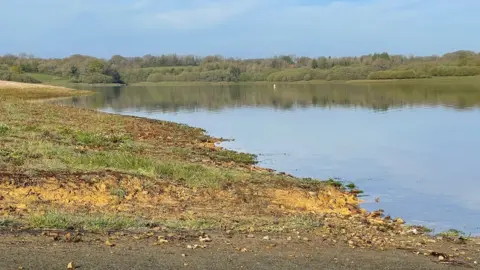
[58,83,480,111]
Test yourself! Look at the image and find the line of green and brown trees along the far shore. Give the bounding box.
[0,50,480,84]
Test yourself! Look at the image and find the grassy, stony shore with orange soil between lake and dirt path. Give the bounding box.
[0,81,476,266]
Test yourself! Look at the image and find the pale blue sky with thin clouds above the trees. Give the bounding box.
[0,0,480,58]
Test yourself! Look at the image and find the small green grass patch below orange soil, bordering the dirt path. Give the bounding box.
[28,211,143,231]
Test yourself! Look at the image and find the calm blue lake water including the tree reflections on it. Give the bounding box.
[62,83,480,235]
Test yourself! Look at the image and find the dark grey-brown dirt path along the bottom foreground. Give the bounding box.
[0,232,477,270]
